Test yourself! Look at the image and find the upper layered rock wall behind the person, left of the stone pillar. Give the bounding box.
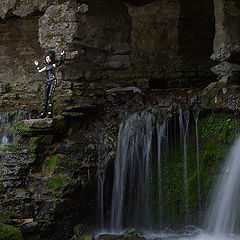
[0,0,216,113]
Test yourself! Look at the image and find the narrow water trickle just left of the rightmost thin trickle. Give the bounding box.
[179,108,190,223]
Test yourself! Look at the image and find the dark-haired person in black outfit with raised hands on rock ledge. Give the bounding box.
[34,50,64,118]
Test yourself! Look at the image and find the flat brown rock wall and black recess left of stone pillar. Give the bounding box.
[128,0,214,88]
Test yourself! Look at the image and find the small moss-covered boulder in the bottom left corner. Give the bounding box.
[0,224,23,240]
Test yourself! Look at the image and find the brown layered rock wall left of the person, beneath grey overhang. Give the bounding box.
[0,17,44,109]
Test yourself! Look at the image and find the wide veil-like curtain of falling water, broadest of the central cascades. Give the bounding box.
[110,111,166,232]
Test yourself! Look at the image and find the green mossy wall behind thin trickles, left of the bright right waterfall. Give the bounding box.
[153,113,240,227]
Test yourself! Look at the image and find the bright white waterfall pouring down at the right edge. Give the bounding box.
[205,137,240,236]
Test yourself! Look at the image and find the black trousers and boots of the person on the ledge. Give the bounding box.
[43,79,56,115]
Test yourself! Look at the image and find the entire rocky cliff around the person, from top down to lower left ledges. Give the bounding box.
[0,0,240,239]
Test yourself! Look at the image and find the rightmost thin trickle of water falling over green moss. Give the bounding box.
[193,108,202,215]
